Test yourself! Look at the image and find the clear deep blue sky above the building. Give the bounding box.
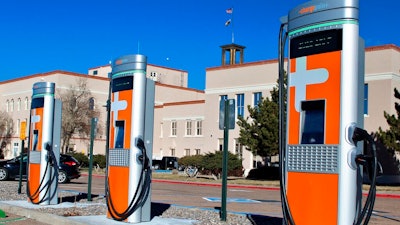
[0,0,400,90]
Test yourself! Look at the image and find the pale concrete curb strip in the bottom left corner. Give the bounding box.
[0,202,85,225]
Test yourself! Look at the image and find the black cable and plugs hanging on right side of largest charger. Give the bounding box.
[352,127,378,225]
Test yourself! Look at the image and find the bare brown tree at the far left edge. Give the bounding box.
[0,111,14,159]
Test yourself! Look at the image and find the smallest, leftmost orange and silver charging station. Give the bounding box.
[27,82,62,205]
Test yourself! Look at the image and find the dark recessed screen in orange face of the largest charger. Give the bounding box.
[301,100,325,144]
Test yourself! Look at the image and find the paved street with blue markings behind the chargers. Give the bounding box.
[60,175,400,225]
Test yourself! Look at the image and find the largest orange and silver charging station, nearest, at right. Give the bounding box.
[279,0,376,225]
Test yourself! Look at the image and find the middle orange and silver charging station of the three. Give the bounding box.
[106,54,155,223]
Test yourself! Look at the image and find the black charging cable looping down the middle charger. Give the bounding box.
[106,138,151,221]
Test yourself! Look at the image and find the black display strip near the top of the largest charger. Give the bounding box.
[290,29,343,59]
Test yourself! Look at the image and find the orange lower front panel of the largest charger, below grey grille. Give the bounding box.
[287,172,339,225]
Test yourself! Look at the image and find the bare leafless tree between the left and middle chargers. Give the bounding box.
[60,78,100,153]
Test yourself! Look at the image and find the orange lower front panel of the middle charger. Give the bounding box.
[107,166,129,218]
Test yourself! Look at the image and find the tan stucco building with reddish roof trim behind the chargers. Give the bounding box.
[0,45,400,169]
